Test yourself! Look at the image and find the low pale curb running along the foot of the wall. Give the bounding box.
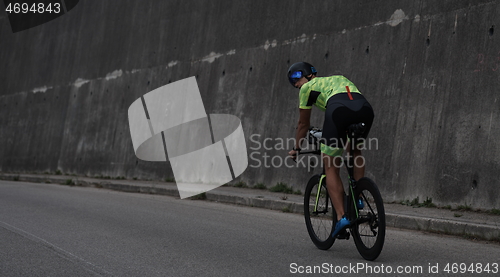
[0,174,500,242]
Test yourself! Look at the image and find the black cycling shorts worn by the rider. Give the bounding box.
[321,93,374,156]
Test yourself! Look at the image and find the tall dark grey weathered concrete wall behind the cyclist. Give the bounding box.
[0,0,500,209]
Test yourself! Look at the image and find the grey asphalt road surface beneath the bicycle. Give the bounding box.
[0,181,500,276]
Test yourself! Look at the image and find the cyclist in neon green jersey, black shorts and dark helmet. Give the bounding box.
[288,62,374,238]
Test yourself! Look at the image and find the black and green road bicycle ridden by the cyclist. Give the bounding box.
[299,123,385,261]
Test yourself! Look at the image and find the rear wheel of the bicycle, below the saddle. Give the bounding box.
[351,178,386,261]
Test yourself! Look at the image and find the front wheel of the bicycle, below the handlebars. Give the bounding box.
[304,175,337,250]
